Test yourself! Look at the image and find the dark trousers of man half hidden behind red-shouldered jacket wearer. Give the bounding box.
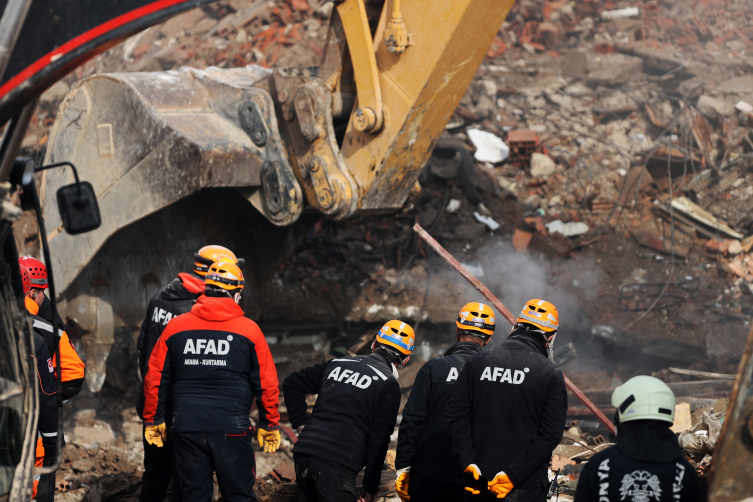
[139,433,183,502]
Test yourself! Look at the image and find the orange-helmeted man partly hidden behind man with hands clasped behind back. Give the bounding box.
[395,302,494,502]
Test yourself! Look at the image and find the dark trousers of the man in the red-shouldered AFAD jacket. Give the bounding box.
[173,432,258,502]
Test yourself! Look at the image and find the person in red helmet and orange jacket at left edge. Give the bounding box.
[18,256,86,404]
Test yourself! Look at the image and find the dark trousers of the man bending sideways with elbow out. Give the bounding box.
[294,455,358,502]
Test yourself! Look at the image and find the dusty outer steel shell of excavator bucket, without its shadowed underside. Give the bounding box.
[43,66,303,291]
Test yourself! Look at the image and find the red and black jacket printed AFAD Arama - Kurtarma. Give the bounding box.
[144,295,280,434]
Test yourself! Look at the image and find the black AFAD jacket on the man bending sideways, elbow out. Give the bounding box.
[282,353,400,494]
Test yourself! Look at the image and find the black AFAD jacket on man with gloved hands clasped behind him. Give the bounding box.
[446,332,567,488]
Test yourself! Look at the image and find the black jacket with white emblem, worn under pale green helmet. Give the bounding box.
[575,420,705,502]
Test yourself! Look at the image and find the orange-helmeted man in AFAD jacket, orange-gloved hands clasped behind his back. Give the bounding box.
[446,300,567,502]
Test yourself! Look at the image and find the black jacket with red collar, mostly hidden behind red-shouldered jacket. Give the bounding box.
[136,273,204,418]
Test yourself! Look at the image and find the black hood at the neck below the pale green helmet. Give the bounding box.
[617,420,682,462]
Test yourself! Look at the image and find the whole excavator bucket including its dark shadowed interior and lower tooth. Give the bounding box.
[41,66,306,391]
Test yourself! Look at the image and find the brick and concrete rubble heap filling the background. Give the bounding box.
[15,0,753,501]
